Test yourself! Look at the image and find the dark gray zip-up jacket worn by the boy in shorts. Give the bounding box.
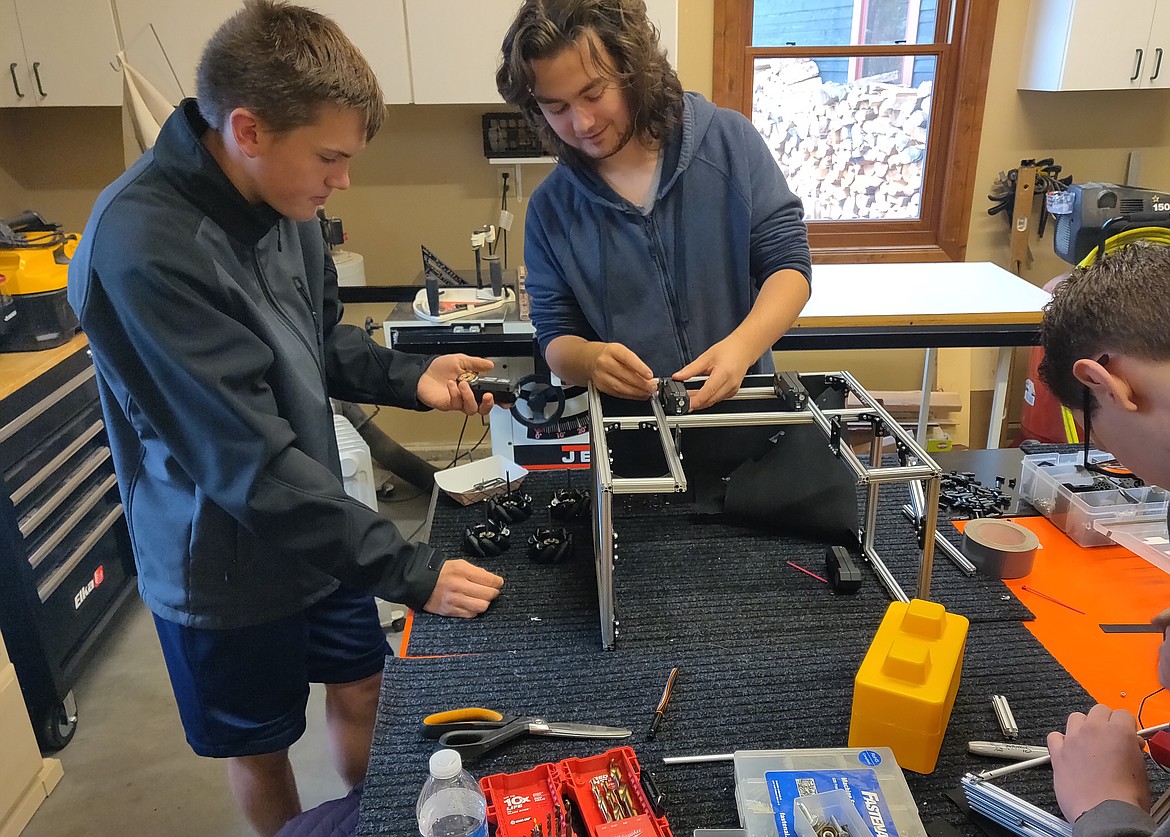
[69,100,442,627]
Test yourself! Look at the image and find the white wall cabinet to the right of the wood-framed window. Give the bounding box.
[1019,0,1170,90]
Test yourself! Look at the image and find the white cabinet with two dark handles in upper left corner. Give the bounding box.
[0,0,122,108]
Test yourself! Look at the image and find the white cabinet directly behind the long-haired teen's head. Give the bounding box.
[405,0,678,104]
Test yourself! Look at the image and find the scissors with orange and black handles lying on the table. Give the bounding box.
[422,706,632,763]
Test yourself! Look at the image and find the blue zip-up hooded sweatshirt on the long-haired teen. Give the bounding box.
[524,94,812,376]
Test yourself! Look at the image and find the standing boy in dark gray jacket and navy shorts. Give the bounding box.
[69,0,503,835]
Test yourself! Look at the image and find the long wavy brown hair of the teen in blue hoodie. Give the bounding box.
[496,0,682,167]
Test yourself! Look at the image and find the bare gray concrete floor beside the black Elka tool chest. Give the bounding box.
[22,483,431,837]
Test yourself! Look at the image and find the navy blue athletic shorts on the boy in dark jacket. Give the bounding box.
[148,586,390,759]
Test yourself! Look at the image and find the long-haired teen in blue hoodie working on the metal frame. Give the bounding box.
[496,0,811,410]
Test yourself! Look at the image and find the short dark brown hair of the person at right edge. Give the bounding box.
[1040,241,1170,410]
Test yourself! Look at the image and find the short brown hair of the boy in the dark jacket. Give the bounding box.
[195,0,386,142]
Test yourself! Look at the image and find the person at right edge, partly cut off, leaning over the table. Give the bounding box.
[1040,241,1170,837]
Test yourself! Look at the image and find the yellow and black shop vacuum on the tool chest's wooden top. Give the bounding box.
[0,212,77,351]
